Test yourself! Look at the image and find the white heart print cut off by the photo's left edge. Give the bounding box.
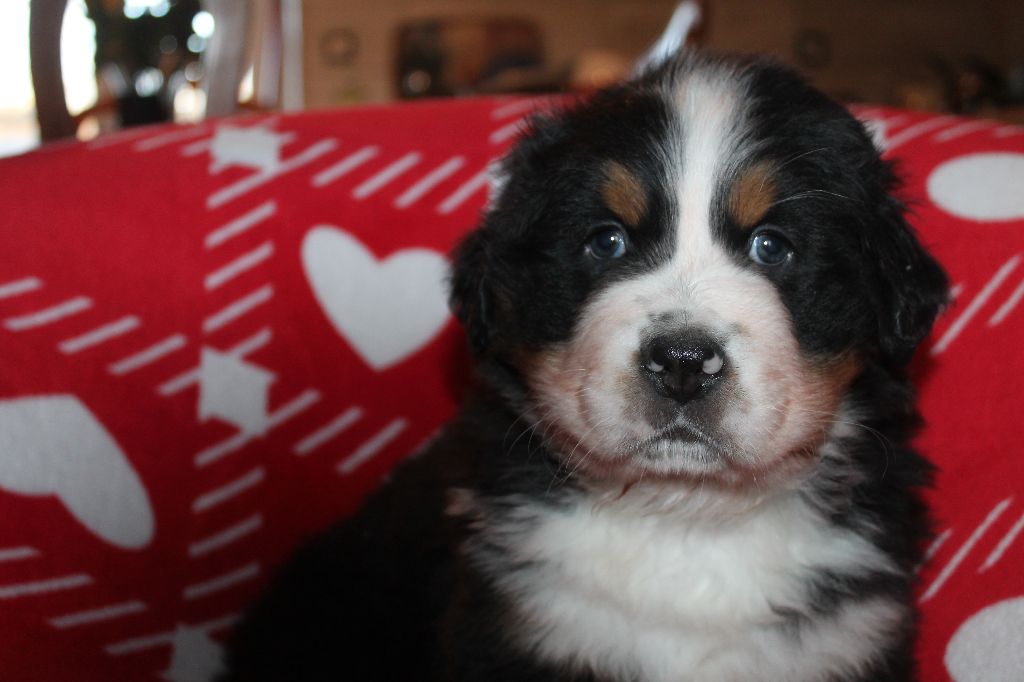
[0,395,155,549]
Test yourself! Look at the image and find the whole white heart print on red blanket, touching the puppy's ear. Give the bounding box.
[302,225,449,372]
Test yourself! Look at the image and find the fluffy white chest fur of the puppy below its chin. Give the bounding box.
[485,489,905,682]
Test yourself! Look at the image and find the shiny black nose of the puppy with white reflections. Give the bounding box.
[640,334,726,402]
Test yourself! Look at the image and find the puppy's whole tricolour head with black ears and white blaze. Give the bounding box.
[454,57,945,481]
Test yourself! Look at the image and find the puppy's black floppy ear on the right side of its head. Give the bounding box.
[866,199,949,366]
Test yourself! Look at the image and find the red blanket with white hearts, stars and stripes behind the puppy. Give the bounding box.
[0,99,1024,682]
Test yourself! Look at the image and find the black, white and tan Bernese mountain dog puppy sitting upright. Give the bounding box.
[224,52,947,682]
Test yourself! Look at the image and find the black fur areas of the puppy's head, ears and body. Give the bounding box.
[222,57,946,682]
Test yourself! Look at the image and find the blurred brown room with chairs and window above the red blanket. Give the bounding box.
[0,0,1024,156]
